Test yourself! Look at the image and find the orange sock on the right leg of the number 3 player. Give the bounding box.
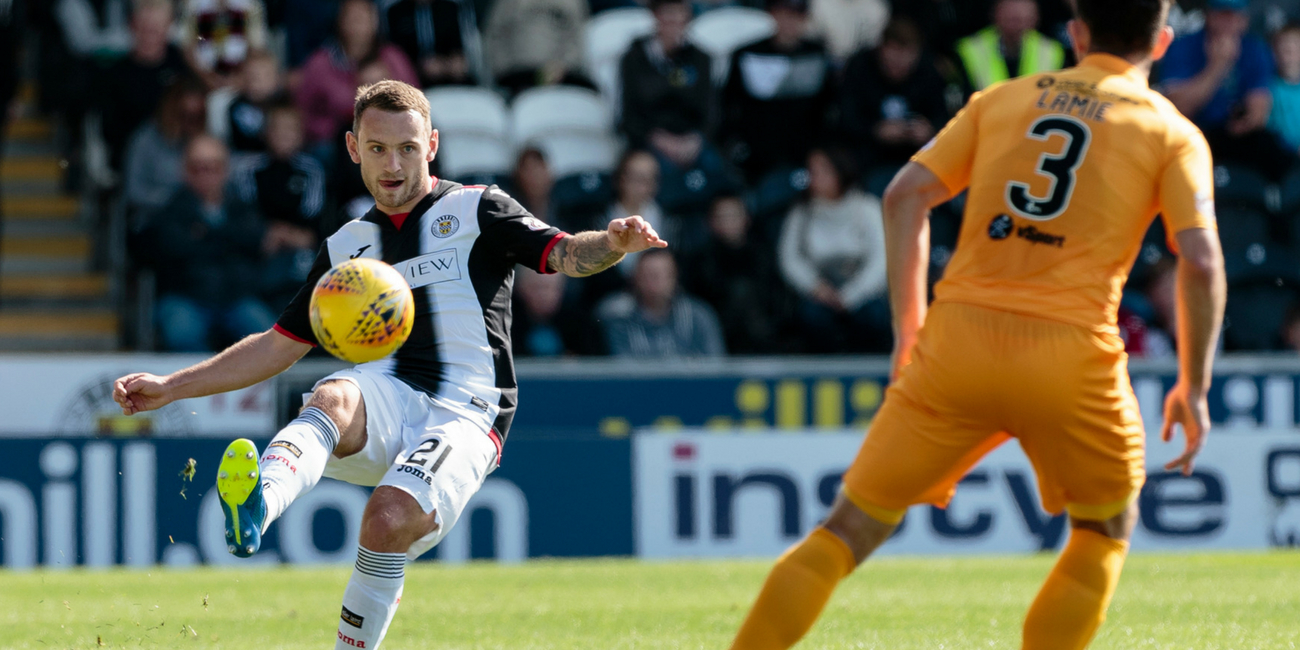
[1021,529,1128,650]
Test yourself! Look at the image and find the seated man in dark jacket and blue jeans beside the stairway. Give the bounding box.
[142,135,276,352]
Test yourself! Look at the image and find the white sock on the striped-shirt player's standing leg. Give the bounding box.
[334,546,406,650]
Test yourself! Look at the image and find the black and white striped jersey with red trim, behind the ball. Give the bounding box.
[276,179,564,439]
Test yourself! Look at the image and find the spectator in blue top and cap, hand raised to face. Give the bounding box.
[1161,0,1294,177]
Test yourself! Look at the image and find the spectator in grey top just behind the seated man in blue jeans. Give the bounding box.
[122,77,208,217]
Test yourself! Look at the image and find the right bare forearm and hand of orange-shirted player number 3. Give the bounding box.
[1160,228,1227,475]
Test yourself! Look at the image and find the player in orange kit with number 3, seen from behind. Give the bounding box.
[732,0,1226,650]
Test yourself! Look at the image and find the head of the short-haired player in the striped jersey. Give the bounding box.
[347,108,438,213]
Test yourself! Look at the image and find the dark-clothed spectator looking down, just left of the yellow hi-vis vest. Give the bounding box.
[841,18,949,191]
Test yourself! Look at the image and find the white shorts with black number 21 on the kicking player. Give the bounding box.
[304,368,501,560]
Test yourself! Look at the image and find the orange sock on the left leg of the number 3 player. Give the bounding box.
[732,527,858,650]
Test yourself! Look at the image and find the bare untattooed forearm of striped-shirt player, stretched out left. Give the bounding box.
[113,330,312,415]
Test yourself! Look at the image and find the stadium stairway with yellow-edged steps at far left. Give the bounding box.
[0,90,118,351]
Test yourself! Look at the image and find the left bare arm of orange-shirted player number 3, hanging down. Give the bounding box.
[884,163,952,377]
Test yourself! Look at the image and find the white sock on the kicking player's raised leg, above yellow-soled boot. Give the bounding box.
[260,407,338,532]
